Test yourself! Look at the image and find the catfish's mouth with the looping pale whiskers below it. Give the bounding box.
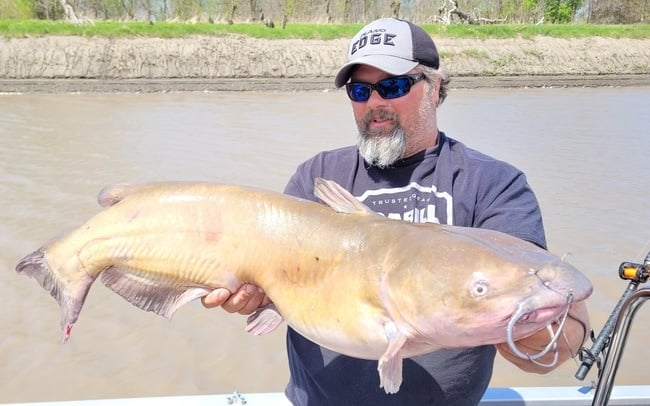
[506,293,574,367]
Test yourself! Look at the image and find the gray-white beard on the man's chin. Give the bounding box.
[357,127,406,169]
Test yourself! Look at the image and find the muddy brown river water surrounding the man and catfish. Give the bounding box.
[0,87,650,403]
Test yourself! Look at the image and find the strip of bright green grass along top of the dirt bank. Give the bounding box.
[0,20,650,39]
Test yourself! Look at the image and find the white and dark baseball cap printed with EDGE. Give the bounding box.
[334,18,440,87]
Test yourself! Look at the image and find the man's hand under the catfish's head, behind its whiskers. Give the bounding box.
[496,301,591,374]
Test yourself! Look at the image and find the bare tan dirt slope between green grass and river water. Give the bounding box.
[0,35,650,92]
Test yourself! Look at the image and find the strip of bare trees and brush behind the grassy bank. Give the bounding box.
[19,0,650,27]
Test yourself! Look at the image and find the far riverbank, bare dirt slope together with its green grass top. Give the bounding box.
[0,20,650,93]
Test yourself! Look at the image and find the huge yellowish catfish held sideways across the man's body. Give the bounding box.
[16,179,592,393]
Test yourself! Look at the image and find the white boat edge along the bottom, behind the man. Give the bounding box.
[2,385,650,406]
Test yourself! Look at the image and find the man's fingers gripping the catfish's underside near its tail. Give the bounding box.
[201,284,271,314]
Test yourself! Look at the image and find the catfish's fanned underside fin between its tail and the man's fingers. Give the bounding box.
[101,267,214,319]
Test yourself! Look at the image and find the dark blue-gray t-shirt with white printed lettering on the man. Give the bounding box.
[285,132,546,406]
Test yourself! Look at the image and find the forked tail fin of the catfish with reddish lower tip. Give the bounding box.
[16,247,95,342]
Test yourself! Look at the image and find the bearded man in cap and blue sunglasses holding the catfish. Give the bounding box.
[203,18,589,405]
